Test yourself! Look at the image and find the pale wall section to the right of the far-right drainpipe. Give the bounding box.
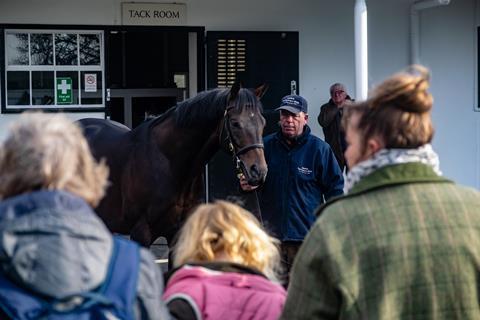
[420,0,480,188]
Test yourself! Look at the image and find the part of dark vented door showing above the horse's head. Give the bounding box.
[207,31,299,134]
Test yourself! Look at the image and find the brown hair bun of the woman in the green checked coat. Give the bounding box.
[371,65,433,113]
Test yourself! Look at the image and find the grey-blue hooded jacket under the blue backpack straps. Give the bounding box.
[0,191,170,319]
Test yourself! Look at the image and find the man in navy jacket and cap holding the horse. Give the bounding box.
[241,95,343,284]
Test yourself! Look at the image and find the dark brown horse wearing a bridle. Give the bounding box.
[78,84,267,246]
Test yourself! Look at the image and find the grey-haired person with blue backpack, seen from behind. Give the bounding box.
[0,113,170,319]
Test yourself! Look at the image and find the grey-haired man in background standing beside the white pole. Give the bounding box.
[318,83,352,171]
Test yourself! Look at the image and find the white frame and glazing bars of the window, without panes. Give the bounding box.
[0,25,107,113]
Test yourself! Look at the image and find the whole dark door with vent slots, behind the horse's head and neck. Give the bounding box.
[207,31,299,211]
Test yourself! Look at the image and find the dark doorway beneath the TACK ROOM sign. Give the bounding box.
[105,27,204,128]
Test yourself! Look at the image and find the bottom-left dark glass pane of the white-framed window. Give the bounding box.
[7,71,30,105]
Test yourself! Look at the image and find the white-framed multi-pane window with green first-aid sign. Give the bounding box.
[2,30,105,110]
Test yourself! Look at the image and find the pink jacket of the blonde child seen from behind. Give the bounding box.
[163,265,286,320]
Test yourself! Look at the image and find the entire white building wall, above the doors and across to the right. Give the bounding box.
[0,0,480,188]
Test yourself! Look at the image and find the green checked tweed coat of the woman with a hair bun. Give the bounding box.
[282,163,480,319]
